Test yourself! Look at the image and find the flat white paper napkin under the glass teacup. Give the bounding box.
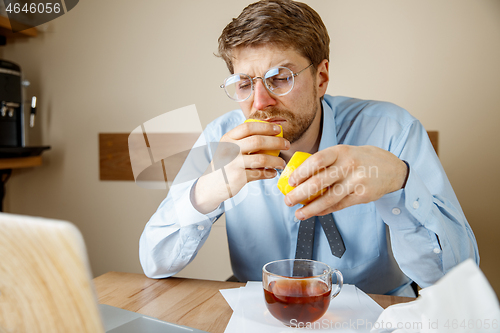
[220,282,383,333]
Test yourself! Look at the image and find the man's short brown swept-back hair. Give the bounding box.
[218,0,330,74]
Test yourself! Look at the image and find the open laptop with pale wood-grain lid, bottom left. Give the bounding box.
[0,213,208,333]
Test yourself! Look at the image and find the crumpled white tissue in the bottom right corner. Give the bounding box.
[371,259,500,333]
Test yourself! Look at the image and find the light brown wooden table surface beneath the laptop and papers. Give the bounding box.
[94,272,414,333]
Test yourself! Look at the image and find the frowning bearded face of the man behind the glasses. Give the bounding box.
[233,45,321,143]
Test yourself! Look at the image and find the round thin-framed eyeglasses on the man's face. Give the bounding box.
[220,64,312,102]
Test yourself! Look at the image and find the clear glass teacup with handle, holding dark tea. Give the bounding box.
[262,259,344,326]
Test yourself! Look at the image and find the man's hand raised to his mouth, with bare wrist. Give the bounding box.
[192,122,290,213]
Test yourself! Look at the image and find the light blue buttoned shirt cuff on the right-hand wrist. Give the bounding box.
[375,162,432,229]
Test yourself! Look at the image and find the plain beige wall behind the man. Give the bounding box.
[0,0,500,293]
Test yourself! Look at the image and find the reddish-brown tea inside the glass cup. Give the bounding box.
[264,278,331,325]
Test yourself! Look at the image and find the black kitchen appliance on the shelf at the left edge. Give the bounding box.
[0,60,50,158]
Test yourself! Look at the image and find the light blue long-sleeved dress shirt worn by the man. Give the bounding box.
[139,95,479,295]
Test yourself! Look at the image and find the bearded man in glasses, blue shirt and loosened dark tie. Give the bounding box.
[140,0,479,296]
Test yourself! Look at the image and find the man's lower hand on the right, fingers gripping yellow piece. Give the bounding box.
[285,145,407,219]
